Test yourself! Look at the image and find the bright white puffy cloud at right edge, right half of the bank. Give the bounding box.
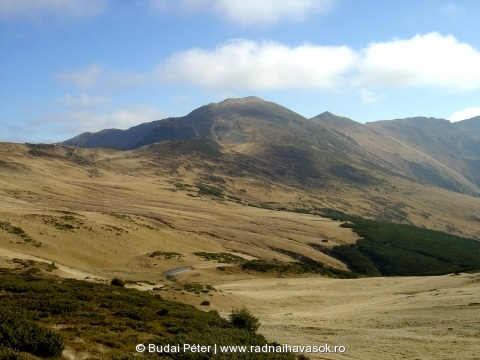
[356,33,480,91]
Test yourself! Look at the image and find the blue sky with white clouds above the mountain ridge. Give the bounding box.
[0,0,480,143]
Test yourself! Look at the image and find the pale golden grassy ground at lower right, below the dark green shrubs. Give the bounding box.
[210,273,480,360]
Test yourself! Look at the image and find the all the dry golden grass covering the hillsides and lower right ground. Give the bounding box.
[0,144,480,359]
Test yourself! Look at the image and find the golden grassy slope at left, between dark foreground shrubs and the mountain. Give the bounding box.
[0,145,357,281]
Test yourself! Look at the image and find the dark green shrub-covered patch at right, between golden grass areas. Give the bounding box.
[316,212,480,276]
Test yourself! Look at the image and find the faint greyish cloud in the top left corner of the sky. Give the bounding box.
[0,0,109,18]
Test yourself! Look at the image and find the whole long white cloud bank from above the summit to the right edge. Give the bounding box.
[157,32,480,93]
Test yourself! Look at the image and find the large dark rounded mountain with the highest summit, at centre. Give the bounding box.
[63,97,377,187]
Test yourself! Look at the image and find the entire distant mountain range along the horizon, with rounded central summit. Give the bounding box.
[61,97,480,196]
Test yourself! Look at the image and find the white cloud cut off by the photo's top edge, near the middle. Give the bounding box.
[149,0,338,25]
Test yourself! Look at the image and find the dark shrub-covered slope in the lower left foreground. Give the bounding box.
[0,269,302,360]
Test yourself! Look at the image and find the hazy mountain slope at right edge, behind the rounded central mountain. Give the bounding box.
[311,113,480,195]
